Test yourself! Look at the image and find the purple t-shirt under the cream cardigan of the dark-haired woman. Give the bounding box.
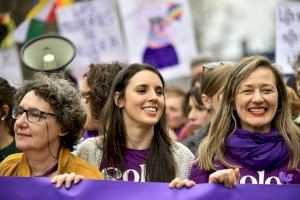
[100,148,150,182]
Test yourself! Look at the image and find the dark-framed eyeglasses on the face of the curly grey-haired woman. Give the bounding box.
[12,106,55,123]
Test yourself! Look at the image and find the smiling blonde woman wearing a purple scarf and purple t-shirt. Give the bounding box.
[190,56,300,187]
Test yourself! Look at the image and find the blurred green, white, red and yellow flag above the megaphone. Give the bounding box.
[13,0,73,43]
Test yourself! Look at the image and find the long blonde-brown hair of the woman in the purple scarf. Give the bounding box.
[198,56,300,170]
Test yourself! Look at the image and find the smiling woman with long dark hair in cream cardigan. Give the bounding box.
[56,64,194,188]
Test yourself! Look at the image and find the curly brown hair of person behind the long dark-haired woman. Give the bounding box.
[83,62,126,119]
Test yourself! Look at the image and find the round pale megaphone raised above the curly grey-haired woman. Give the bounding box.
[20,34,76,71]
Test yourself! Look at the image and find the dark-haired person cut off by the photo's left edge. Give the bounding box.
[0,77,20,162]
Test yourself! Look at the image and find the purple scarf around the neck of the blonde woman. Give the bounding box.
[226,128,289,170]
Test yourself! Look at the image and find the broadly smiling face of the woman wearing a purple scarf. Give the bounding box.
[234,67,278,133]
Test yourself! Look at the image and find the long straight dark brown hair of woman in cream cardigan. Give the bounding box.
[100,64,176,182]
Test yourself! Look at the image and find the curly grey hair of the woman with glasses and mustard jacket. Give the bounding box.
[15,72,86,151]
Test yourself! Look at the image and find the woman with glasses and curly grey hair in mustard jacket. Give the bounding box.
[0,74,102,179]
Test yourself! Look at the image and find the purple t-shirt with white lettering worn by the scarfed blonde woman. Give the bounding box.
[189,156,300,185]
